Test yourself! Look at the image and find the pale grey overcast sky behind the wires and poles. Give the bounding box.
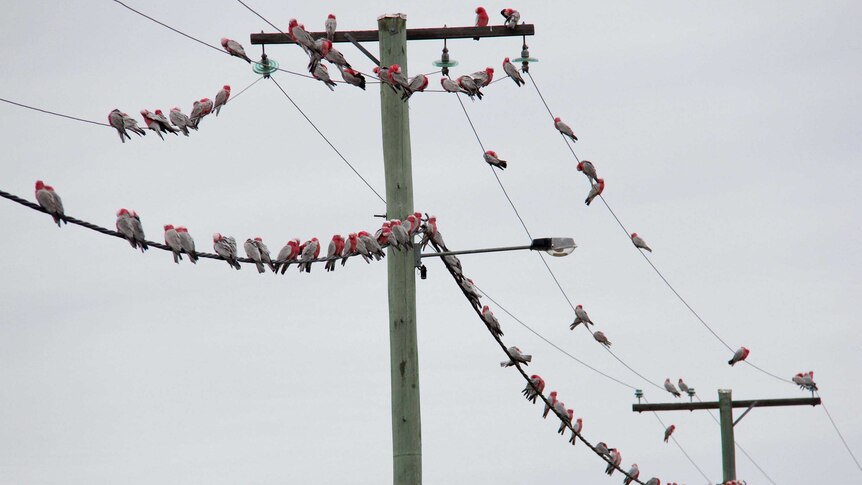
[0,0,862,485]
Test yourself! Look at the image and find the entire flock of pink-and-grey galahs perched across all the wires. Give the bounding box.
[23,7,818,485]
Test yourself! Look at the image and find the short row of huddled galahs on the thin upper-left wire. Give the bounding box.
[108,83,236,143]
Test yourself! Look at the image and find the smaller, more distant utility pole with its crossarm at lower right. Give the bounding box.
[632,389,820,483]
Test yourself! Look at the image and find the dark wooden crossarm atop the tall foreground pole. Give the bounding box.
[251,24,536,45]
